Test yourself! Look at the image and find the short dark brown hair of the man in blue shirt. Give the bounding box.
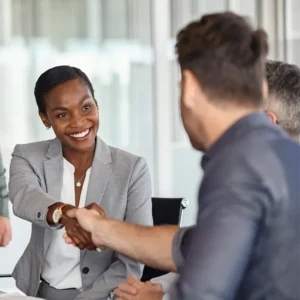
[176,12,268,107]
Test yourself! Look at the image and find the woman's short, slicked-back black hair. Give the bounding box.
[34,66,95,114]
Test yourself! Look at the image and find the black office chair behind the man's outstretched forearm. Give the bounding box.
[141,198,188,281]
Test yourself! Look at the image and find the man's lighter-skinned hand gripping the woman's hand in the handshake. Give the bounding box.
[64,203,105,250]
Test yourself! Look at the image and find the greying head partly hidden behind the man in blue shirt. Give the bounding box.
[265,60,300,137]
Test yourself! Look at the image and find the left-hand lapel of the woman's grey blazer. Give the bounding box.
[43,139,63,254]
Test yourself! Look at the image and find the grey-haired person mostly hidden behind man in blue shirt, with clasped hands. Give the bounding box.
[114,60,300,300]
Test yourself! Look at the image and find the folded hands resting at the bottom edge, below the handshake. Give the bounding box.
[114,275,164,300]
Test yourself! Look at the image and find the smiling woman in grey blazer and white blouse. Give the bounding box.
[9,66,152,300]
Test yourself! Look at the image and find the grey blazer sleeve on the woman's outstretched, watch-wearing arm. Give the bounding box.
[8,145,58,229]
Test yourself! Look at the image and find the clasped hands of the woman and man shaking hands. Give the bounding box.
[54,203,106,250]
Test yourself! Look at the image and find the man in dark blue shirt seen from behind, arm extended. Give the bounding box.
[66,13,300,300]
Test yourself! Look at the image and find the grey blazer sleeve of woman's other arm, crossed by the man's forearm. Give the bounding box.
[75,158,153,300]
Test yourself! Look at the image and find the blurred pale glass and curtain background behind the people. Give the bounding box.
[0,0,300,291]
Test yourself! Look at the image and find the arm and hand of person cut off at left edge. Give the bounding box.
[0,149,12,247]
